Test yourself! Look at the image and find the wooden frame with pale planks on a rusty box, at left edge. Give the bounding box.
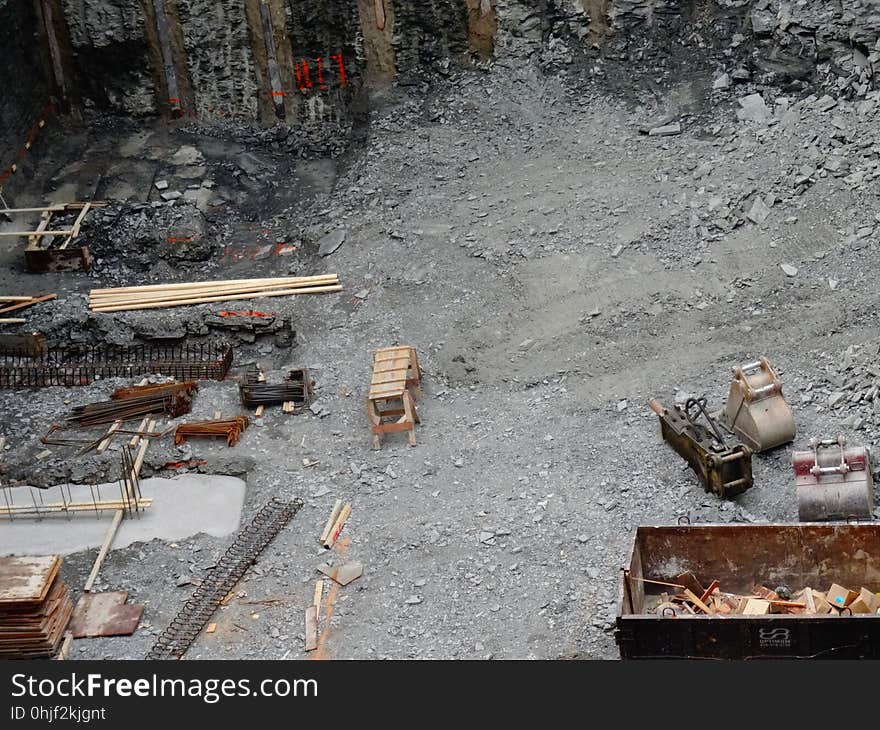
[0,202,106,274]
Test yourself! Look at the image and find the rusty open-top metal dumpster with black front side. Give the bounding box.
[615,523,880,659]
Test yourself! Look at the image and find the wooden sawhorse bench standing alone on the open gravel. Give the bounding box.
[367,345,422,449]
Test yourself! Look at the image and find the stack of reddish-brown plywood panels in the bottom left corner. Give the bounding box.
[0,555,73,659]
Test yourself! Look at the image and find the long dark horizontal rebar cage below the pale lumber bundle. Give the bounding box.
[0,343,233,388]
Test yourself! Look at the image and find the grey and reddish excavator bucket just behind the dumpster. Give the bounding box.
[792,436,874,522]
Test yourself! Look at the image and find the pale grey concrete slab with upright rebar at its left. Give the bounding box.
[0,474,245,555]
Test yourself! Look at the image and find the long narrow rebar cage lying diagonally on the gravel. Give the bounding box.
[146,499,303,659]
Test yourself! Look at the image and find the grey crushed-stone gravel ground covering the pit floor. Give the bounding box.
[0,44,880,659]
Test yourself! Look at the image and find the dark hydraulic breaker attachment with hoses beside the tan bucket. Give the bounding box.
[648,398,752,498]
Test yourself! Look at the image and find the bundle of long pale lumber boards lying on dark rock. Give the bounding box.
[89,274,342,312]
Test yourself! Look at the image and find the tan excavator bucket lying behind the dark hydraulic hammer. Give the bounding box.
[720,357,795,451]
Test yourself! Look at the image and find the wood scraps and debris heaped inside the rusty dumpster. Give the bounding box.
[645,572,880,616]
